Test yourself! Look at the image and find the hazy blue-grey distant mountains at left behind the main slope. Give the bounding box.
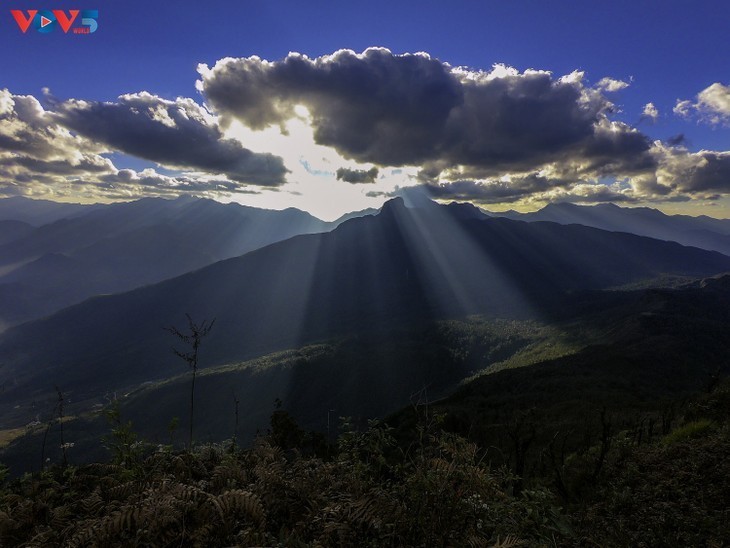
[0,197,357,325]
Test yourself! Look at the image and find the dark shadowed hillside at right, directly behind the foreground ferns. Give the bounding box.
[390,275,730,465]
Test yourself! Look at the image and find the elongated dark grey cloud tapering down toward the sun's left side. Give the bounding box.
[54,93,287,186]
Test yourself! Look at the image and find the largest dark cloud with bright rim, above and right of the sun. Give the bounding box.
[197,48,649,178]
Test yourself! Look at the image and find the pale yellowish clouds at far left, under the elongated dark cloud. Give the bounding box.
[0,90,276,200]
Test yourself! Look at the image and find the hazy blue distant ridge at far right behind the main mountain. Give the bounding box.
[489,203,730,255]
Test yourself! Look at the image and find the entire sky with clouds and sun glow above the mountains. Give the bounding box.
[0,0,730,220]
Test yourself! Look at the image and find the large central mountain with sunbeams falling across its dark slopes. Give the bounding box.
[0,199,730,428]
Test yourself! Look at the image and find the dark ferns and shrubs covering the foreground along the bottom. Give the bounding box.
[0,383,730,547]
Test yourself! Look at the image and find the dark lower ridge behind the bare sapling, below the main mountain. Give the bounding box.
[2,317,553,471]
